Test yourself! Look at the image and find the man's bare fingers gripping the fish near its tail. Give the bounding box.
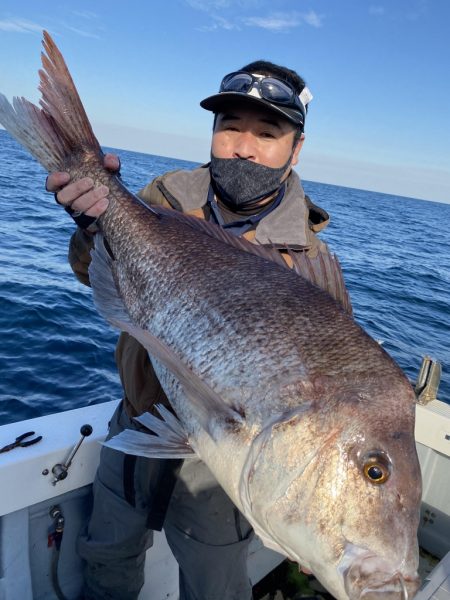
[46,154,120,218]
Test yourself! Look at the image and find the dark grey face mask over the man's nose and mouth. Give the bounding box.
[209,151,294,209]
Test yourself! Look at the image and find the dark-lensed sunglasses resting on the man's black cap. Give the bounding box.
[219,71,305,117]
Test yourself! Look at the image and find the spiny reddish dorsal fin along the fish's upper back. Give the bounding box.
[152,206,352,315]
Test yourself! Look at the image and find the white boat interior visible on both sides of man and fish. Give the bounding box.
[0,401,450,600]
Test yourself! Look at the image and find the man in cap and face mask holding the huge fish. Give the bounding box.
[47,61,328,600]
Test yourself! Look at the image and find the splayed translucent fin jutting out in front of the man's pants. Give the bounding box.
[103,404,195,458]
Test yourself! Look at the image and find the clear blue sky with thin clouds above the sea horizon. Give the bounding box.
[0,0,450,202]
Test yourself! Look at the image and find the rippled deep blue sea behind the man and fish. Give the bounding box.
[0,131,450,424]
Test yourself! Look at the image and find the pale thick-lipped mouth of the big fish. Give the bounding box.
[343,554,420,600]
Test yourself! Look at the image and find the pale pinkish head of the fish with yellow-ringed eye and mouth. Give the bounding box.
[243,382,421,600]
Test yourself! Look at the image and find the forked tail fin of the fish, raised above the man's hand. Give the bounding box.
[0,31,101,171]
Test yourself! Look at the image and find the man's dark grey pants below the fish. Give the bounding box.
[78,404,252,600]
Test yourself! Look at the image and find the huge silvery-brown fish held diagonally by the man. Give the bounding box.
[0,33,421,600]
